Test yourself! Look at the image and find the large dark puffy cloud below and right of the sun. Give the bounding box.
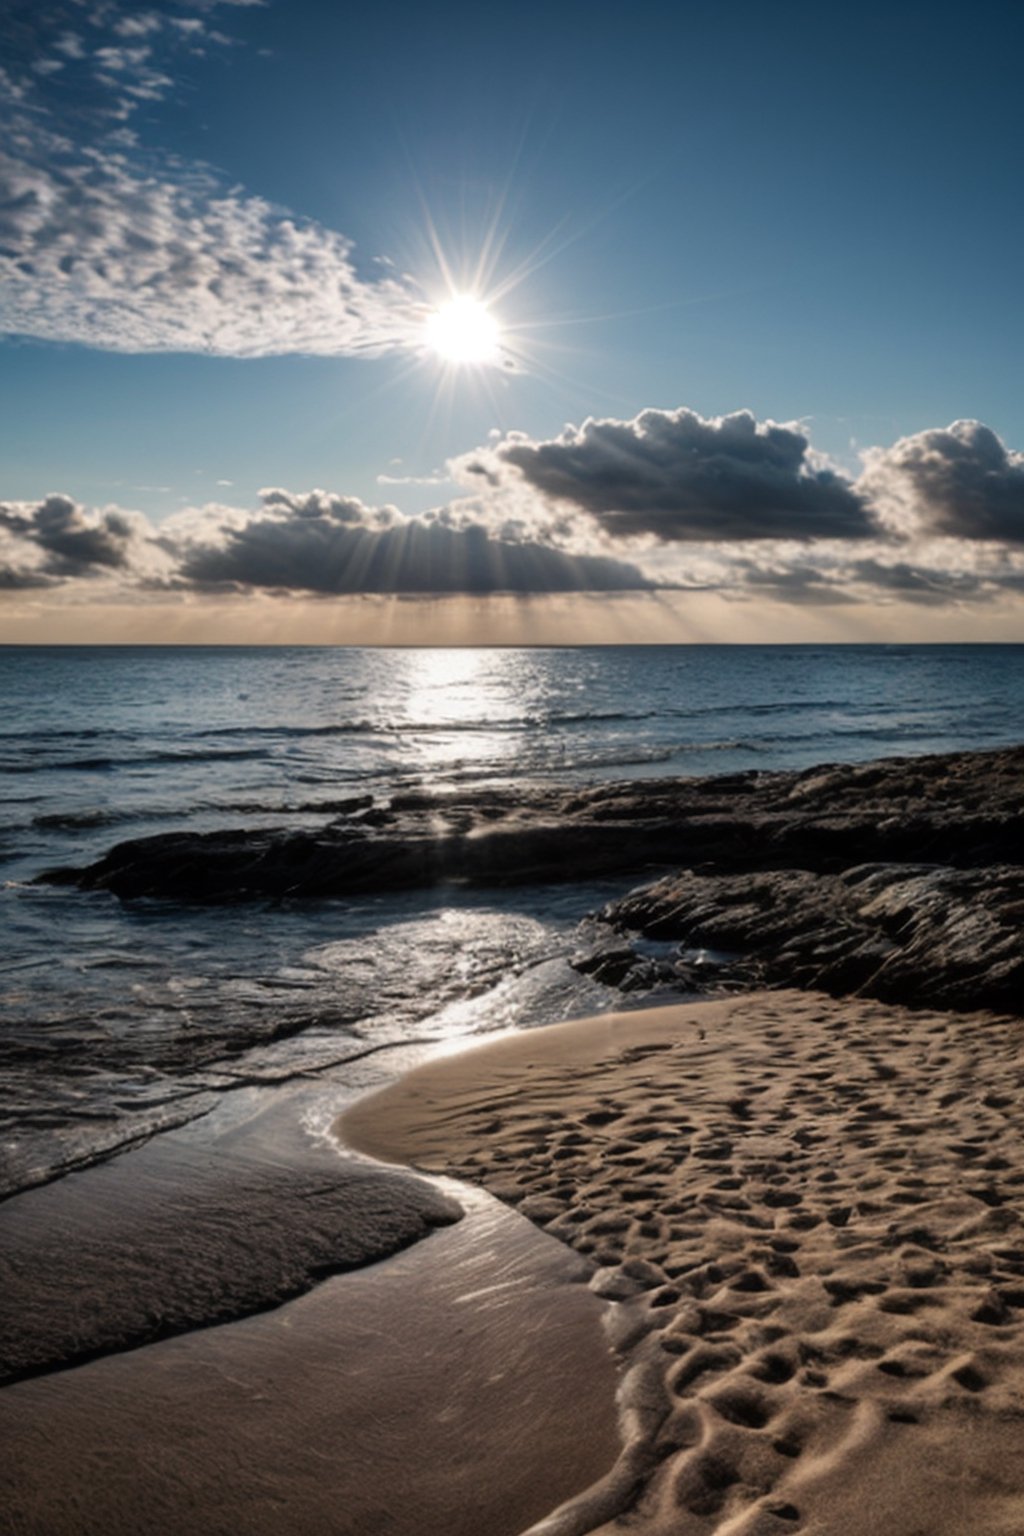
[453,407,877,542]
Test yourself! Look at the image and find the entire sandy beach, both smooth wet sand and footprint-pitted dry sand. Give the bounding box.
[8,991,1024,1536]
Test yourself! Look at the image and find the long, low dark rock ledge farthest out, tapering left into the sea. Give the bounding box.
[41,748,1024,902]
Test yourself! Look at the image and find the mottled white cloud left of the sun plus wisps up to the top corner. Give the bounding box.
[0,0,425,358]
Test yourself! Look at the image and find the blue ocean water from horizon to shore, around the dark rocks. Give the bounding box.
[0,645,1024,1190]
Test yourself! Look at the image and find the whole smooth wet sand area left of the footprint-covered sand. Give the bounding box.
[0,1095,619,1536]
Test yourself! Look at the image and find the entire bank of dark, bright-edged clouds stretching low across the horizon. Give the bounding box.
[8,412,1024,607]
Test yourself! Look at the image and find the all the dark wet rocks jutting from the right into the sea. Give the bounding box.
[40,746,1024,1011]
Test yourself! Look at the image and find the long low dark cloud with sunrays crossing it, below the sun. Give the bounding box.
[172,492,651,596]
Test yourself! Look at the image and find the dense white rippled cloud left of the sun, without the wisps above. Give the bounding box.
[0,129,421,358]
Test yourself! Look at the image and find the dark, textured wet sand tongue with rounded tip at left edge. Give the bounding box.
[0,1087,461,1381]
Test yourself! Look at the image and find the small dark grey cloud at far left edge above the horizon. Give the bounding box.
[0,496,149,578]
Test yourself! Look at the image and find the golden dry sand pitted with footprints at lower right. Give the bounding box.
[339,992,1024,1536]
